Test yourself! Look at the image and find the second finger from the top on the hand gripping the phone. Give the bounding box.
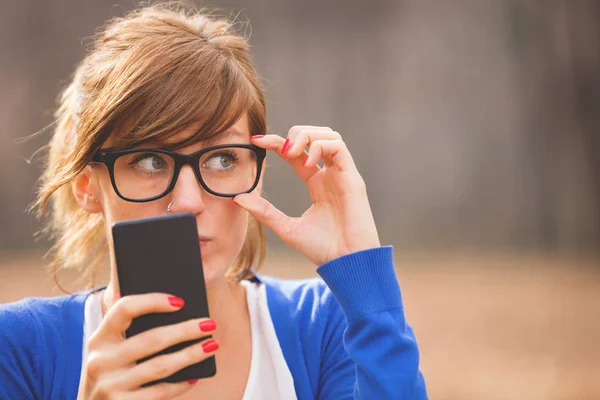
[115,318,216,365]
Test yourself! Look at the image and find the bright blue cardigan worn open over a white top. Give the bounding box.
[0,247,427,400]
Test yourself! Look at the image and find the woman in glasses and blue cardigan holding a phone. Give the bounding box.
[0,5,427,399]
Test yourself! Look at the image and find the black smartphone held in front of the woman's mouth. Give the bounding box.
[112,213,217,386]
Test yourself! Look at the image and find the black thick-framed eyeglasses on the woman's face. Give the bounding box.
[92,144,266,203]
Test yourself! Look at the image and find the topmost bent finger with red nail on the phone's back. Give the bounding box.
[96,293,183,339]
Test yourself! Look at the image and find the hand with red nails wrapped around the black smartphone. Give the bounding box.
[78,293,218,400]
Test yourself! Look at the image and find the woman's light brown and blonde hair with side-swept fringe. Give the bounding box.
[33,3,266,287]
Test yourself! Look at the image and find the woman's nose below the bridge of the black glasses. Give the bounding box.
[171,165,208,214]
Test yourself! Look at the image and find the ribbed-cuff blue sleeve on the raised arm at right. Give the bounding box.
[317,247,427,400]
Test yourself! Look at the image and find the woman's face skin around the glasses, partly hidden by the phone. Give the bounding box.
[90,115,261,286]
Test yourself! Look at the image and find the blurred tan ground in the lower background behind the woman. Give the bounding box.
[0,253,600,400]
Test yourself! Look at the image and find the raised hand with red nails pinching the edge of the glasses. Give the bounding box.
[234,126,380,265]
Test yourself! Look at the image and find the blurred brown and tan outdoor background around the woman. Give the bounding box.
[0,0,600,400]
